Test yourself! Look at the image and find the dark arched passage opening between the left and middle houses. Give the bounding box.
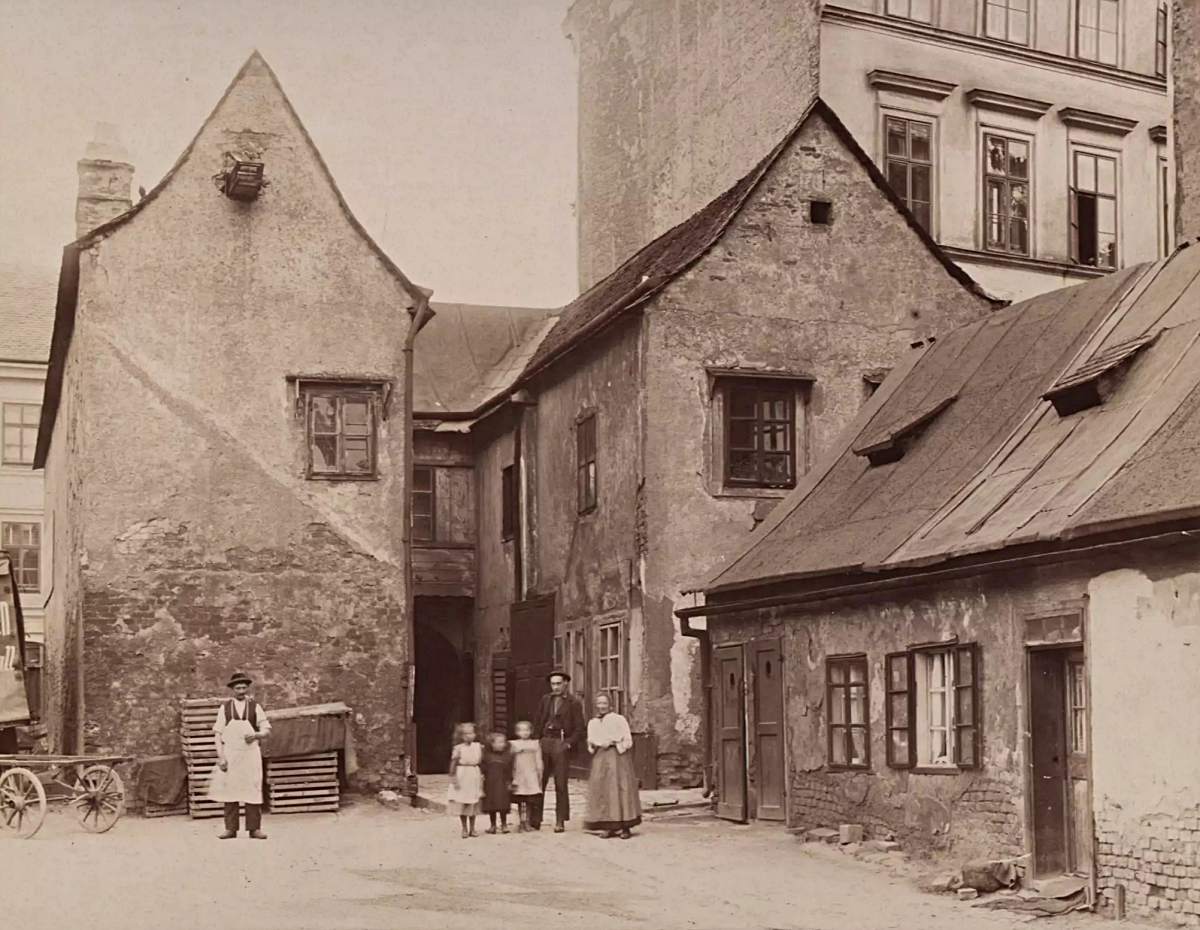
[413,620,472,775]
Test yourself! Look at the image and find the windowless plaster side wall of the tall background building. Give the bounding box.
[564,0,820,289]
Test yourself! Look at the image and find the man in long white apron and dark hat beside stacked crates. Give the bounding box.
[209,672,271,840]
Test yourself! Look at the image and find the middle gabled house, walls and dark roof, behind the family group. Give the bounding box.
[446,102,994,784]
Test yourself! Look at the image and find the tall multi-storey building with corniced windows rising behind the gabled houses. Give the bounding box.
[565,0,1171,300]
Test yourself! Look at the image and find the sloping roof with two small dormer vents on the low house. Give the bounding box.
[706,247,1200,594]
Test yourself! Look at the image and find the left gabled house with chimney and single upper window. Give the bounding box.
[35,53,422,785]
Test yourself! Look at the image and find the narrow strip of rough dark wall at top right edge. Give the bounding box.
[1171,0,1200,242]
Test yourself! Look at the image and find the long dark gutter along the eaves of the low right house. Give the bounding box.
[674,528,1200,635]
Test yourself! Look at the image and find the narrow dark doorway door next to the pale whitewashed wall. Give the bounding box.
[1030,648,1092,876]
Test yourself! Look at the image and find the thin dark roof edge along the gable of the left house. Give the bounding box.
[34,50,427,468]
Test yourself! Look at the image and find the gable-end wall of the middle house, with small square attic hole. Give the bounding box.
[643,111,989,792]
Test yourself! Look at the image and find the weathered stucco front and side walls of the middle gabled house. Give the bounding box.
[475,106,992,784]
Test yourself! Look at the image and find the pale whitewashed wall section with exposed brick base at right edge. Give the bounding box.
[1088,558,1200,925]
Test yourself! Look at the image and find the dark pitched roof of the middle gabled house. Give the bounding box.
[524,97,1007,386]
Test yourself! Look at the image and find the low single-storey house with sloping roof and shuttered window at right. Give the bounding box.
[680,232,1200,923]
